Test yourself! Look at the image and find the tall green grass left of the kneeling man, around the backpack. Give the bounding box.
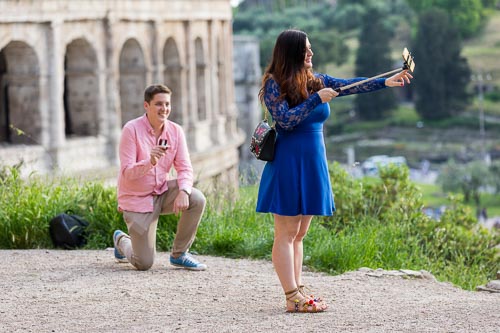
[0,168,126,249]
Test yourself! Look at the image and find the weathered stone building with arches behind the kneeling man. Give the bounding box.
[0,0,245,193]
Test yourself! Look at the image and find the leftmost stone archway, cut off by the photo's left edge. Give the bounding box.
[0,41,42,144]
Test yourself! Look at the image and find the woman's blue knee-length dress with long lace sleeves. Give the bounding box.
[256,74,385,216]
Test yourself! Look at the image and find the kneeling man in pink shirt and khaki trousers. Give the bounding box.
[113,85,207,270]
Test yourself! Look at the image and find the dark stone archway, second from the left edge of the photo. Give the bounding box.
[64,38,99,137]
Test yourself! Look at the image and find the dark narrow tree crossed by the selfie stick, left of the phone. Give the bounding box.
[355,8,396,120]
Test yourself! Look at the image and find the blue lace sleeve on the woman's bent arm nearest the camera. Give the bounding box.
[264,79,321,131]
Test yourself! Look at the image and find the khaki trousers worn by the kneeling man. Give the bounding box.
[118,180,206,270]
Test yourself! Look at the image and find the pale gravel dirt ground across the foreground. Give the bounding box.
[0,249,500,333]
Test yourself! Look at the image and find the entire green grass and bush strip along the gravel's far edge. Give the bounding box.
[0,164,500,290]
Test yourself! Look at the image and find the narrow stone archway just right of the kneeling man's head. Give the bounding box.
[163,38,183,125]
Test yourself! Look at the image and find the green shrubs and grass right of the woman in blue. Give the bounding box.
[318,164,500,289]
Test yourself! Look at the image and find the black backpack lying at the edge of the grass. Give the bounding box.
[49,213,89,250]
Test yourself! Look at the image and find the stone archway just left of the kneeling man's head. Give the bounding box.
[119,39,147,126]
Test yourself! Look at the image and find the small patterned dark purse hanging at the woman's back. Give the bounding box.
[250,111,276,161]
